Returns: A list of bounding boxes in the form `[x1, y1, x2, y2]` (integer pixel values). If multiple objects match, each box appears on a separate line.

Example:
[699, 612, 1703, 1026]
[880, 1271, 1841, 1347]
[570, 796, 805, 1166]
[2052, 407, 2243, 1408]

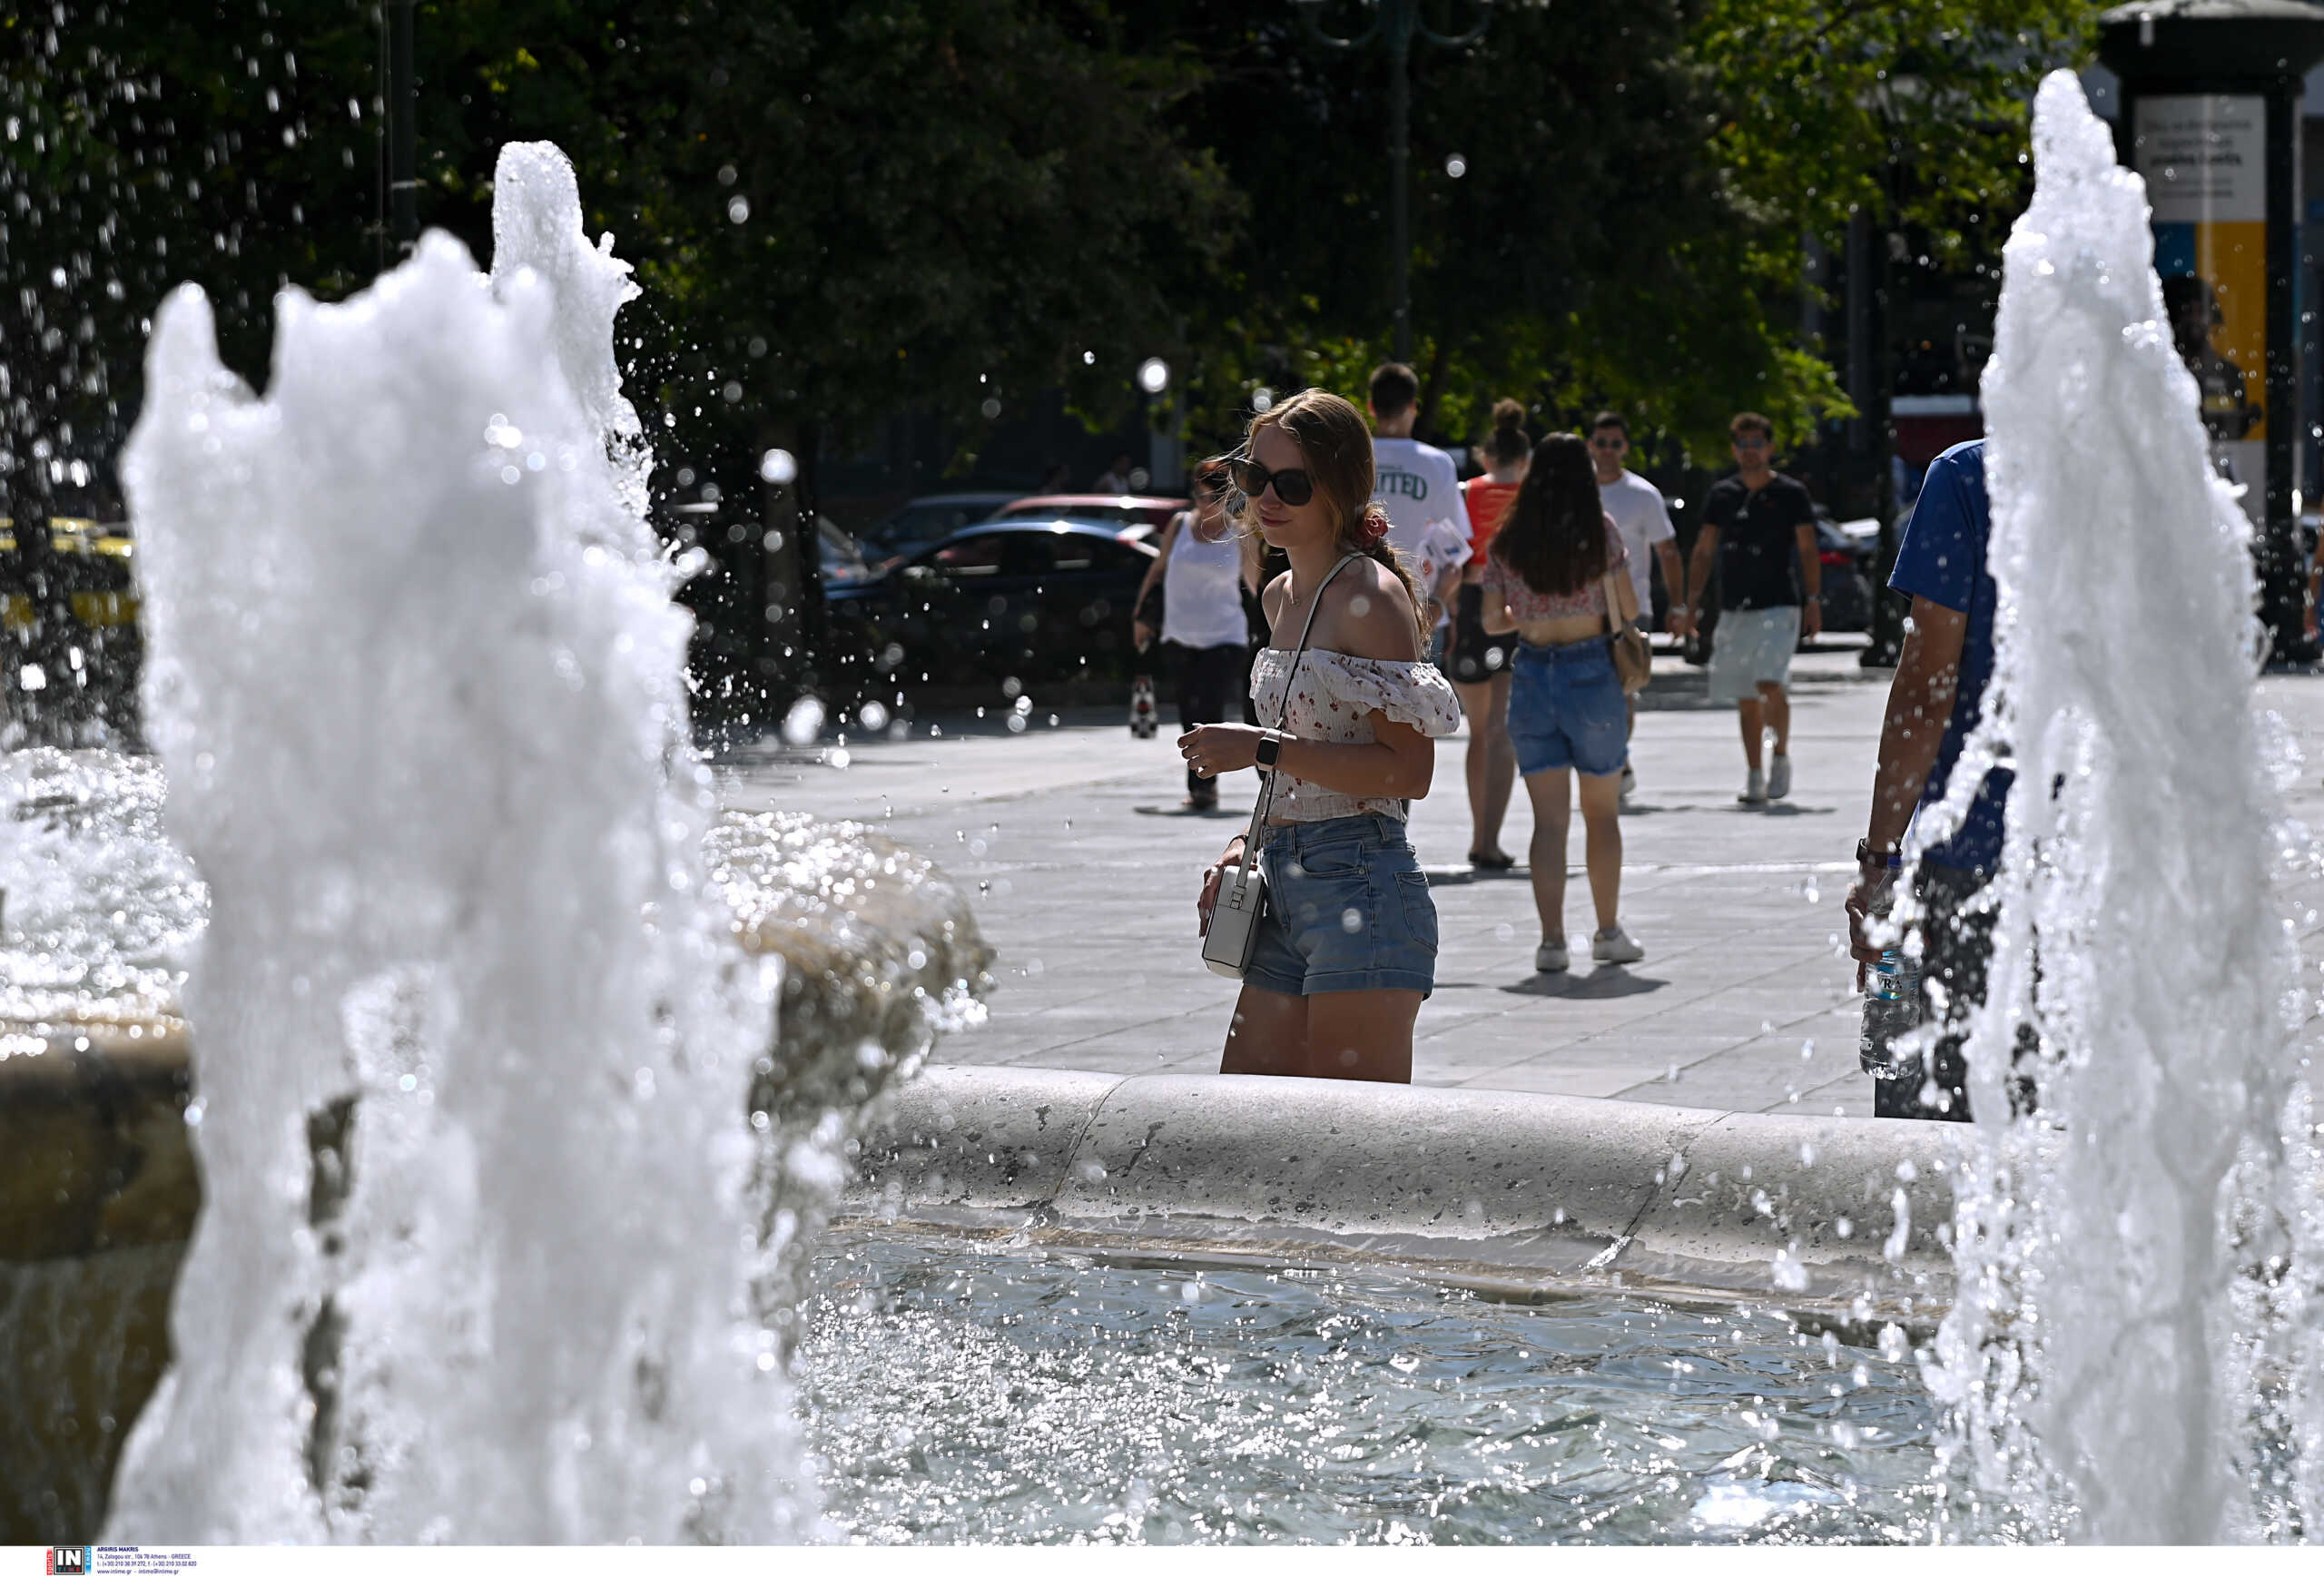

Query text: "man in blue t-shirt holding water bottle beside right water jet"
[1847, 439, 2010, 1122]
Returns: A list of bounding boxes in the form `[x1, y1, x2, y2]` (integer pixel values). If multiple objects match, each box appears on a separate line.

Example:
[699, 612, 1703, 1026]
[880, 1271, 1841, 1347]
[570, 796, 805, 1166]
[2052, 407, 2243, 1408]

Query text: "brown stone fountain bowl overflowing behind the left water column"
[0, 793, 990, 1544]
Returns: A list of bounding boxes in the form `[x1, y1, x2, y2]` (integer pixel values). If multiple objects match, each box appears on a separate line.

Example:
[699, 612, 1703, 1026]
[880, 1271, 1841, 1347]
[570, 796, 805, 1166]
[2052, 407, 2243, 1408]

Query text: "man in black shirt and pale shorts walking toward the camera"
[1688, 411, 1825, 806]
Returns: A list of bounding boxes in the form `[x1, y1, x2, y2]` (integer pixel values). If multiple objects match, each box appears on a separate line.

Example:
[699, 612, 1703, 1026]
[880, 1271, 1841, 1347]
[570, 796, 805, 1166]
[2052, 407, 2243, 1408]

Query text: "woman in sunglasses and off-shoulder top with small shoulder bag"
[1178, 388, 1460, 1085]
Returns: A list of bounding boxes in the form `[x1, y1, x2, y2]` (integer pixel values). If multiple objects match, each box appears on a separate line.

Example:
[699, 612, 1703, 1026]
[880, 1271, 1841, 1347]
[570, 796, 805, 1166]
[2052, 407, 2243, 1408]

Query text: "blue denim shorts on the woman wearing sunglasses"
[1244, 815, 1436, 996]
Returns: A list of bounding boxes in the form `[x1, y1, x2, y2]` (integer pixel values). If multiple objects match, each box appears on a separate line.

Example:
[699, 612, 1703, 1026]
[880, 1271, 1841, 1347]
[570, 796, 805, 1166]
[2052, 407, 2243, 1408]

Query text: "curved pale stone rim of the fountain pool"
[842, 1066, 1966, 1326]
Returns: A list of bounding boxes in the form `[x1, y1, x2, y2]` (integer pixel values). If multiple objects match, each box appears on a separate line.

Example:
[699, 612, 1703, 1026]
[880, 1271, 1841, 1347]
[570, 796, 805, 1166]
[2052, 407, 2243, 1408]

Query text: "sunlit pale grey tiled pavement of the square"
[721, 650, 2324, 1117]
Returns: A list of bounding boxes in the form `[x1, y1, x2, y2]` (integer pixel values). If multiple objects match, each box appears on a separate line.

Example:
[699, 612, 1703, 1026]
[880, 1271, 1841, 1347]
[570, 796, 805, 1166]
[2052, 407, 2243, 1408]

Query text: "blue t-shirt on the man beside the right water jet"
[1889, 439, 2010, 871]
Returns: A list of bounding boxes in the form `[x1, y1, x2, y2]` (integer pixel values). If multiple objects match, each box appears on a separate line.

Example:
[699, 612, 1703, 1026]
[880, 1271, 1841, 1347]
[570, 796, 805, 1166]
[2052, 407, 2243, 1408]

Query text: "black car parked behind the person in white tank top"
[825, 520, 1155, 685]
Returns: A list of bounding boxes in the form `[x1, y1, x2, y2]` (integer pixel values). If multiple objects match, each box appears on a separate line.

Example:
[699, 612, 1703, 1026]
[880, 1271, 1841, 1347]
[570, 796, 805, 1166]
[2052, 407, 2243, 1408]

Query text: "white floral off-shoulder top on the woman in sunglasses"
[1250, 646, 1460, 823]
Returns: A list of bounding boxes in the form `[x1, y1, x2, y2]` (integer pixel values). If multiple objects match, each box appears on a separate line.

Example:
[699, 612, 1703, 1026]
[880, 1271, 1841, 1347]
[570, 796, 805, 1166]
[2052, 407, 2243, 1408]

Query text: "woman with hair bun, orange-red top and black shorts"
[1445, 399, 1534, 871]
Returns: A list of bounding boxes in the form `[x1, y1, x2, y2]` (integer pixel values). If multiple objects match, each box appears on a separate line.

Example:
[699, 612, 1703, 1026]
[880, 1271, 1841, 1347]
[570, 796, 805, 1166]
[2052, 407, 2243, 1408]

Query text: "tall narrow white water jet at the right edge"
[1929, 72, 2324, 1543]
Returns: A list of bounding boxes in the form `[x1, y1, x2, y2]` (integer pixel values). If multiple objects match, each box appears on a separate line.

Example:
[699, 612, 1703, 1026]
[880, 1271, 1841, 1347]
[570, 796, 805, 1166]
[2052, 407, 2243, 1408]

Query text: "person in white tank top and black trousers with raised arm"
[1132, 460, 1257, 811]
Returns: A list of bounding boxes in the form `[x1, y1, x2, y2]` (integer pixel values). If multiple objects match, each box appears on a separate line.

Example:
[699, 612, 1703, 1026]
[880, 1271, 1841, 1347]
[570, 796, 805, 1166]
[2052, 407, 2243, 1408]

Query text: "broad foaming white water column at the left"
[107, 144, 813, 1543]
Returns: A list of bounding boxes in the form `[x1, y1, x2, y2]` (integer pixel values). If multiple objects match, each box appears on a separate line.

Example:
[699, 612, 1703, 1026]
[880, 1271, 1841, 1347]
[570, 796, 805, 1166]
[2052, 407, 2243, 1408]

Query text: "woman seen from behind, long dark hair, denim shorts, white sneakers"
[1485, 432, 1645, 973]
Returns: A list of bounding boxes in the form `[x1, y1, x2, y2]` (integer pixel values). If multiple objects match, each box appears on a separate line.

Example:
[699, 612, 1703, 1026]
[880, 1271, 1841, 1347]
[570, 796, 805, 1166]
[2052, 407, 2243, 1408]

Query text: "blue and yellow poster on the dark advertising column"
[2132, 93, 2269, 520]
